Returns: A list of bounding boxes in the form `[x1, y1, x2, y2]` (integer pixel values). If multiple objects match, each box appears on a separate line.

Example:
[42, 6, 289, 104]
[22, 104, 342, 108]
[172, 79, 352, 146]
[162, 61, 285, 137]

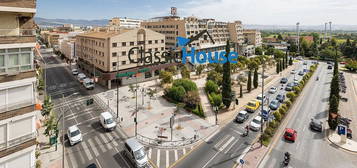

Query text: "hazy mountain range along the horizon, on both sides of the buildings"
[35, 17, 357, 32]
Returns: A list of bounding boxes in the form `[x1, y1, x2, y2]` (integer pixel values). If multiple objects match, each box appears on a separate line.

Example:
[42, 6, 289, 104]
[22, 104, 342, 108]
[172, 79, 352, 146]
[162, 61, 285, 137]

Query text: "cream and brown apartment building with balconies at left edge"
[0, 0, 39, 168]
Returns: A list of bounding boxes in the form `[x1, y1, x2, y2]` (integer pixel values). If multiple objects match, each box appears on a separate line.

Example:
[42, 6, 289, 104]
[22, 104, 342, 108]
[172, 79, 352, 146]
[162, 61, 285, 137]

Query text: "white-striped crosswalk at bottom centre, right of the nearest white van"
[147, 146, 193, 168]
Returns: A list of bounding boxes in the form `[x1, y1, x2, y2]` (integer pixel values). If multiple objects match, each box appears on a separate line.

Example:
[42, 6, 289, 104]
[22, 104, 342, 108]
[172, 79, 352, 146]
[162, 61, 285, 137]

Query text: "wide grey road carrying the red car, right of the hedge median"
[260, 63, 357, 168]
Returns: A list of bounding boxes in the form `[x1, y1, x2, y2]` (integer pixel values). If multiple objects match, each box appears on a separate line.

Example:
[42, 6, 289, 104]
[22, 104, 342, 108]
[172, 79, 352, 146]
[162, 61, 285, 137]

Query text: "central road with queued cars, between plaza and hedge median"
[174, 59, 306, 168]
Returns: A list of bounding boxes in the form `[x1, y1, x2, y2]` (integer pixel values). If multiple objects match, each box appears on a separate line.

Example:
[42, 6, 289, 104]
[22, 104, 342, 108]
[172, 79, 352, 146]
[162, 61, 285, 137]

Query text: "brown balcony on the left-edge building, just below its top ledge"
[0, 29, 36, 44]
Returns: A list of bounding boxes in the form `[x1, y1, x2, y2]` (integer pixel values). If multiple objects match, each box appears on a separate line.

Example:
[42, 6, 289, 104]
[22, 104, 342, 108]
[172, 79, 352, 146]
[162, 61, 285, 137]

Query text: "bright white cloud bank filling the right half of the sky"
[179, 0, 357, 25]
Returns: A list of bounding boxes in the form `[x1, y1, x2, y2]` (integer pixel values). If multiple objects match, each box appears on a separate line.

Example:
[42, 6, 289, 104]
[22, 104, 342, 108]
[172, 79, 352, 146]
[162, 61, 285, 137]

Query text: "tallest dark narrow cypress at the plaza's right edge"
[222, 41, 232, 108]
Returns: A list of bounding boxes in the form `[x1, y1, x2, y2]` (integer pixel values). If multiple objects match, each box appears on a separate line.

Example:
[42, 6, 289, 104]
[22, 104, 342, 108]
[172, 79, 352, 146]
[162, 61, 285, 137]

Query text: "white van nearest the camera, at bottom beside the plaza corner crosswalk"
[124, 138, 149, 168]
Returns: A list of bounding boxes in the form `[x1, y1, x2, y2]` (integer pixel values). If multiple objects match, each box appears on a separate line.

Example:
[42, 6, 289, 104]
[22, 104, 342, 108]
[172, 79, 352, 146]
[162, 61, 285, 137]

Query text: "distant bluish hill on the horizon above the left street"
[35, 17, 109, 26]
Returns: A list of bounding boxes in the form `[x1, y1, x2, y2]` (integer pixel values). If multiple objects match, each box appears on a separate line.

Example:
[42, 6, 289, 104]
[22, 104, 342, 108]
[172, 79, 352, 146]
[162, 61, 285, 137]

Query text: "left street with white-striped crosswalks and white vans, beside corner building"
[43, 53, 133, 168]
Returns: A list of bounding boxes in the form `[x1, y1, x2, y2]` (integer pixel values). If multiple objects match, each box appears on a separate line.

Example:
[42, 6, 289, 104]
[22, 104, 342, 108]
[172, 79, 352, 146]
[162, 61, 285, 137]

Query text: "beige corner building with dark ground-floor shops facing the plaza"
[76, 28, 176, 89]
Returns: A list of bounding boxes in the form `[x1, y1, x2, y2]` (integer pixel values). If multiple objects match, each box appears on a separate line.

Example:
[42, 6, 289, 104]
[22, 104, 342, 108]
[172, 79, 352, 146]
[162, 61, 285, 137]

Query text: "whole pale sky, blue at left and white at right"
[36, 0, 357, 25]
